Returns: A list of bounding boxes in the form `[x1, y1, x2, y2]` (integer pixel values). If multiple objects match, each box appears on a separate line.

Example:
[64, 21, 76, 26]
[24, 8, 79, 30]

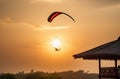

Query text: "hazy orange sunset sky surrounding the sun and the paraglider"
[0, 0, 120, 72]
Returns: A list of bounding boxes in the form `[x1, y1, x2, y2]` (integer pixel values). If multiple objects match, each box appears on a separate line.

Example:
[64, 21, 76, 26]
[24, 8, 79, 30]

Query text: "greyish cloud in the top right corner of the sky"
[74, 0, 120, 10]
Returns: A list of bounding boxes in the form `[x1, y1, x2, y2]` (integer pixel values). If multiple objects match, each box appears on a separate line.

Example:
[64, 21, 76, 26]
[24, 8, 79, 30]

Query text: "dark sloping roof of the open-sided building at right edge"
[73, 37, 120, 60]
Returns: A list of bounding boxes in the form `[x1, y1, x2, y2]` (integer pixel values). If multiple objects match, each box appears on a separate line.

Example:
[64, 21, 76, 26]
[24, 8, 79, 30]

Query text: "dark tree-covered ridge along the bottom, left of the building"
[0, 70, 98, 79]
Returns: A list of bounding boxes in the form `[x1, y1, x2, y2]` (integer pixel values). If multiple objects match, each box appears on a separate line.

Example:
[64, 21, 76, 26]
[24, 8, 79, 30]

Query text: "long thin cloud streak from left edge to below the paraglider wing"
[0, 17, 69, 30]
